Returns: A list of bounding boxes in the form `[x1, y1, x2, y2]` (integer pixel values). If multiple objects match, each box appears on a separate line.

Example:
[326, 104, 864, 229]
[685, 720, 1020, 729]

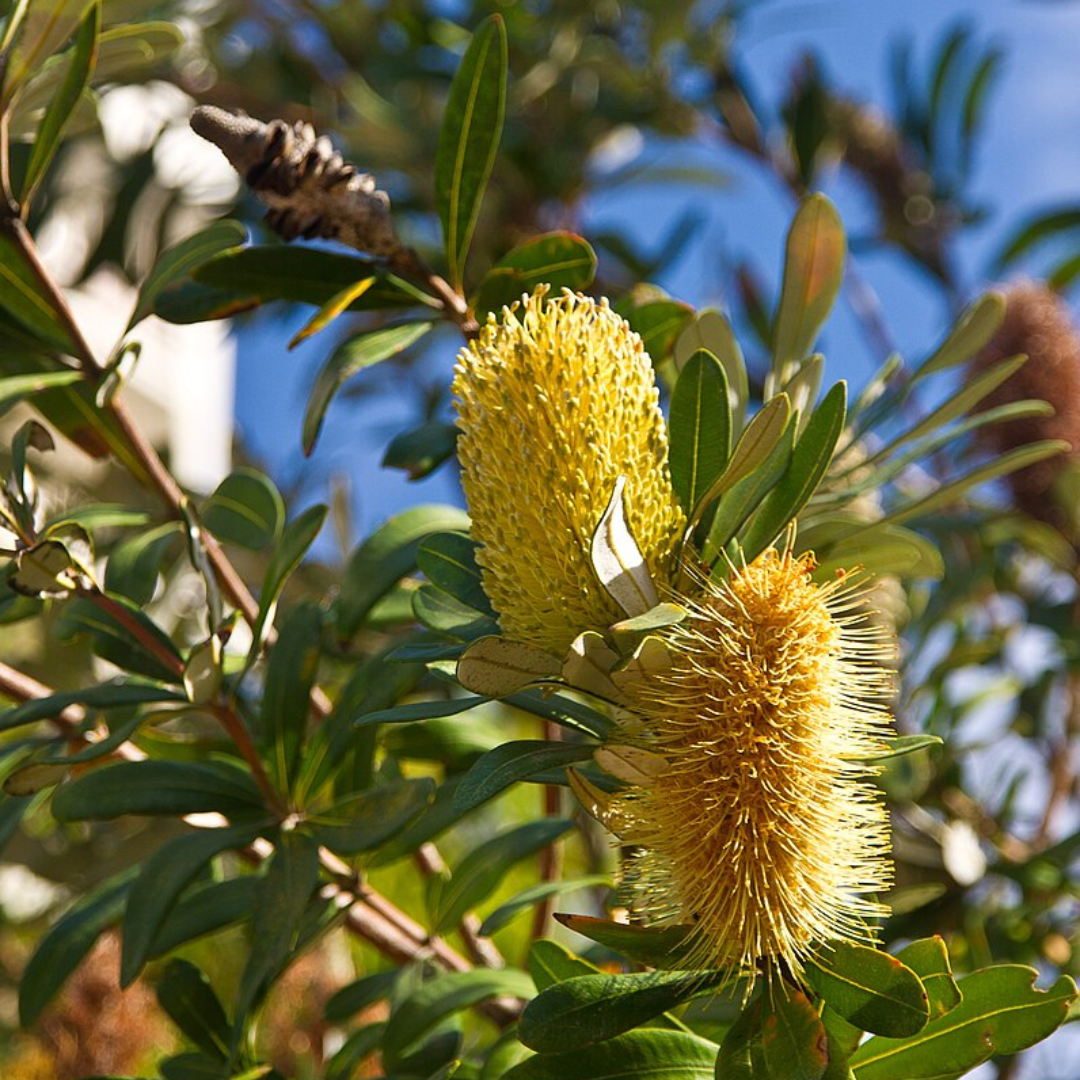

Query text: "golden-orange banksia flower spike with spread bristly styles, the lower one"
[612, 550, 894, 980]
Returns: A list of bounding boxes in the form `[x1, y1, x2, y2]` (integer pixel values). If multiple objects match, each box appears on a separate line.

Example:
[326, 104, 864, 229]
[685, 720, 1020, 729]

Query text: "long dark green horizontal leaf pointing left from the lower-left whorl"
[53, 761, 262, 821]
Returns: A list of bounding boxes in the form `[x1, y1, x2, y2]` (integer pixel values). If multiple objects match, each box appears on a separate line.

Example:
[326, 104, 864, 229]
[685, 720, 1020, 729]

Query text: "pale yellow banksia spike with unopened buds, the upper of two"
[454, 287, 685, 656]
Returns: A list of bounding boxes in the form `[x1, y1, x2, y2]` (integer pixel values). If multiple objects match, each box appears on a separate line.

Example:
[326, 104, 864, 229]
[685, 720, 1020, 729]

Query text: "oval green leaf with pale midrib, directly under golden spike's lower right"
[806, 942, 930, 1039]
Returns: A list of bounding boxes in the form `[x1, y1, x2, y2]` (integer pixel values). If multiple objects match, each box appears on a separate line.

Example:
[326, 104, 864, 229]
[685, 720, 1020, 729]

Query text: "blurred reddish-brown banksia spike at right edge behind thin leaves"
[970, 282, 1080, 528]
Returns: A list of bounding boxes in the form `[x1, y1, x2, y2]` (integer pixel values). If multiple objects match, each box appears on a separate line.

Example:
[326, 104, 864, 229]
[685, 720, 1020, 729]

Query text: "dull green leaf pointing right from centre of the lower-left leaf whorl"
[309, 777, 435, 855]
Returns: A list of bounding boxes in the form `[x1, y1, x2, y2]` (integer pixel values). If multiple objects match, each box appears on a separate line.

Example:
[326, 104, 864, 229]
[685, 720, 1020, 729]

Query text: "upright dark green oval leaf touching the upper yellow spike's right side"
[669, 350, 731, 515]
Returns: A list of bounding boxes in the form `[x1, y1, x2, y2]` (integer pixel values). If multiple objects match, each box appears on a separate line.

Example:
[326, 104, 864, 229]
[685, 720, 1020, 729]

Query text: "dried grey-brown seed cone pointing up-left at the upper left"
[191, 105, 406, 260]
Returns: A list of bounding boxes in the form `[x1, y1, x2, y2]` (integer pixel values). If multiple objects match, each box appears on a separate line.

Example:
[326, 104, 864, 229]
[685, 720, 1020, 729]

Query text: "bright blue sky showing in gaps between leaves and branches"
[237, 0, 1080, 540]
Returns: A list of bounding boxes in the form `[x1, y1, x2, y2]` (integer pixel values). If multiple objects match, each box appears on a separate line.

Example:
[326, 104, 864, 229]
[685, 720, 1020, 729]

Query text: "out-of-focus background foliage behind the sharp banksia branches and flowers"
[0, 0, 1080, 1080]
